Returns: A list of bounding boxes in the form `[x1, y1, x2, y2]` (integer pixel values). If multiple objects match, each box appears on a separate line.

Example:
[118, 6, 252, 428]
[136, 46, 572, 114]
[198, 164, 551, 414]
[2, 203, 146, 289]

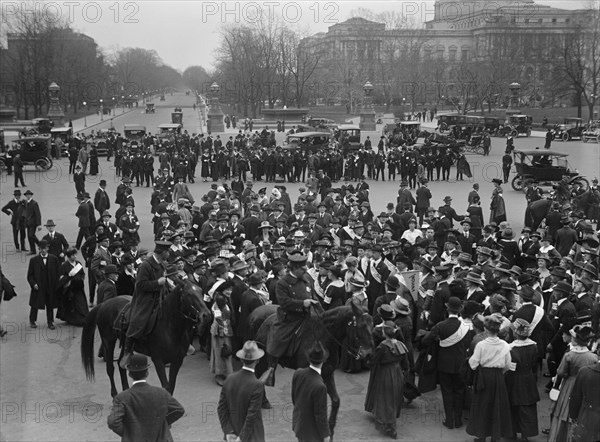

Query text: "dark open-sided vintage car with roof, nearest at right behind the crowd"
[511, 149, 590, 191]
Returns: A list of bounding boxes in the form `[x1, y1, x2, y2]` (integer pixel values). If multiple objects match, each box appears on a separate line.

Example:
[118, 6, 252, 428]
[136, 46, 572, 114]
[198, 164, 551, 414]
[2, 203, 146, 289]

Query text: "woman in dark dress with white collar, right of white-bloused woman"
[505, 318, 540, 441]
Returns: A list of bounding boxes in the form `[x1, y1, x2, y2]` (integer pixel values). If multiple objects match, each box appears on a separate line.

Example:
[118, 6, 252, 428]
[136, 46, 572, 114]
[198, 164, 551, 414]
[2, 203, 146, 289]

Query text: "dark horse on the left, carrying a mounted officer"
[81, 281, 211, 397]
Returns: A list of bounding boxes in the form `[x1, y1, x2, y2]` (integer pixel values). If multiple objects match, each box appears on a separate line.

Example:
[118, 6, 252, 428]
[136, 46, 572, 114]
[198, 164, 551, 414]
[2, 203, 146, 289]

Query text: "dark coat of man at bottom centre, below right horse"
[292, 367, 329, 441]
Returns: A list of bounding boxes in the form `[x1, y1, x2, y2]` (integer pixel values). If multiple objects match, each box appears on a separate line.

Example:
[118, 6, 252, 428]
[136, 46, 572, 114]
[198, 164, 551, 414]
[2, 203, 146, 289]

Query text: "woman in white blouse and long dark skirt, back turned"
[467, 315, 513, 441]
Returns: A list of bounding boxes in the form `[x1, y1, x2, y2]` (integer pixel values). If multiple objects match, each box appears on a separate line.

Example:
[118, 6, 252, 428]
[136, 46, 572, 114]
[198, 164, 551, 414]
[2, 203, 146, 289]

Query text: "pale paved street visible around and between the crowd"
[0, 94, 600, 441]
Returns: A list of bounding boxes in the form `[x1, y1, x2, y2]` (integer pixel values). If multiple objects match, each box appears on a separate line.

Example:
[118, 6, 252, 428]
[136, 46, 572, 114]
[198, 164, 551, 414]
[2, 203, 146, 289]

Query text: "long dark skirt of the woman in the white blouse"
[467, 367, 514, 439]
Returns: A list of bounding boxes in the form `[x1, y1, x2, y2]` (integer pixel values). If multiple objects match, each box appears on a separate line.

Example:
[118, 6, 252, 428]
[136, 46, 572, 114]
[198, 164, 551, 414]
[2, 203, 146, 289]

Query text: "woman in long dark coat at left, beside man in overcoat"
[56, 248, 89, 326]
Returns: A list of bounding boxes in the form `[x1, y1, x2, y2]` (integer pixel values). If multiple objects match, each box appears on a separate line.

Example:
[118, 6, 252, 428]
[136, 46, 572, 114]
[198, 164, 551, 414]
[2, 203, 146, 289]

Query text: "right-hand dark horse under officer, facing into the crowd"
[248, 304, 374, 440]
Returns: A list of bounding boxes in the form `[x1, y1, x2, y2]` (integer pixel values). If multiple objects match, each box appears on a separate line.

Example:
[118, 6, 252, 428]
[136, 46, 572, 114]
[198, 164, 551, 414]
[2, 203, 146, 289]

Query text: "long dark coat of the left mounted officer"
[127, 256, 165, 338]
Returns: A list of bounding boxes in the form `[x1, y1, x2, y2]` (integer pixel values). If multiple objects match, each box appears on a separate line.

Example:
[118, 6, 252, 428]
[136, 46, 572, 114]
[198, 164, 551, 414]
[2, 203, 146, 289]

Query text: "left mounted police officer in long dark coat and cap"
[119, 241, 172, 368]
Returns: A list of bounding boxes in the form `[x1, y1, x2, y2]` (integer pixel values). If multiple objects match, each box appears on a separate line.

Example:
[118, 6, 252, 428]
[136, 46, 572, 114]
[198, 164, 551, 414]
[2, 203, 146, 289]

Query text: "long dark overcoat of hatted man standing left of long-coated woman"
[27, 254, 60, 310]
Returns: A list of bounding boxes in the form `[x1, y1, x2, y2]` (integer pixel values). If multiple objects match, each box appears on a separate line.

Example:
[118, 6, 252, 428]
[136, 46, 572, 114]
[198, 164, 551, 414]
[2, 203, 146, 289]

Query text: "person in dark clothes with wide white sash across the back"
[423, 296, 474, 429]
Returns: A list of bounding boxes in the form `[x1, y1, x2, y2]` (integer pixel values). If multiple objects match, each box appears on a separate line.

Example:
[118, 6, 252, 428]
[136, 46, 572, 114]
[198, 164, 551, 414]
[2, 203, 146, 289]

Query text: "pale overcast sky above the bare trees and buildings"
[19, 0, 598, 71]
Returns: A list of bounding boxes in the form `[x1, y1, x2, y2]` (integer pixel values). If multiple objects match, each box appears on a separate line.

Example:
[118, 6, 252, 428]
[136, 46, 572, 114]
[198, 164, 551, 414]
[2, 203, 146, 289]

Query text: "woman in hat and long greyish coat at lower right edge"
[548, 325, 598, 442]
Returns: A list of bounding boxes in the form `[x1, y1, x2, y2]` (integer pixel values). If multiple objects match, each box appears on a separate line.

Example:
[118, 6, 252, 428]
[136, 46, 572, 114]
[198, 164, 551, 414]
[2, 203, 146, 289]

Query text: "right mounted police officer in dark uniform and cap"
[265, 250, 322, 387]
